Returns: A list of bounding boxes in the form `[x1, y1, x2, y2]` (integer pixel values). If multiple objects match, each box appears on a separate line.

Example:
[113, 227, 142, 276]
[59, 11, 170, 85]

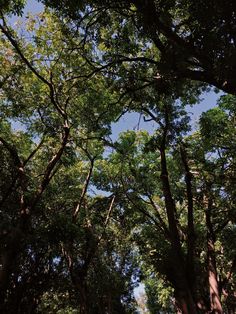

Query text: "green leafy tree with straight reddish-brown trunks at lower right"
[93, 93, 235, 313]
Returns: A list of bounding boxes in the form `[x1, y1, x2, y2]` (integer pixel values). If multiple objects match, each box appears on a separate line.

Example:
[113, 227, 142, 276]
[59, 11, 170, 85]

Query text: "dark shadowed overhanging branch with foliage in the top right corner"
[43, 0, 236, 95]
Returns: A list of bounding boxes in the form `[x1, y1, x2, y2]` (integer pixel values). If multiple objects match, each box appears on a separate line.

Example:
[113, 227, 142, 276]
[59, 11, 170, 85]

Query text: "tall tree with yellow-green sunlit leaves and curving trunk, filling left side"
[0, 12, 136, 313]
